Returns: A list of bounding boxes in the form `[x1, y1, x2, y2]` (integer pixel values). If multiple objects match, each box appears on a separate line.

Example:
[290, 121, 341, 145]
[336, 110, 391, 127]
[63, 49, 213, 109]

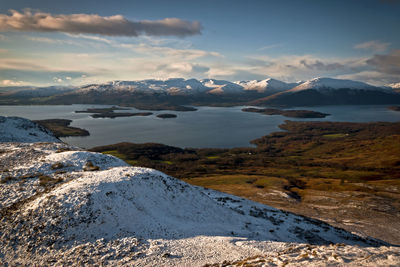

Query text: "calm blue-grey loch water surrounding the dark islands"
[0, 105, 400, 148]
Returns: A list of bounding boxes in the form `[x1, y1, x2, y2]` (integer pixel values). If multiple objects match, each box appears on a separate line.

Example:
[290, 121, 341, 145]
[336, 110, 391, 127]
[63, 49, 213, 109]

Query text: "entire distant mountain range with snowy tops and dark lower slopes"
[0, 78, 400, 109]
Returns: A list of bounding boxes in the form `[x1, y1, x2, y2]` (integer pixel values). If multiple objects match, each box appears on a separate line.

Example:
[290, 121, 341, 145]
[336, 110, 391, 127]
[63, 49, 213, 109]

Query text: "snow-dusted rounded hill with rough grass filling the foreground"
[0, 117, 400, 266]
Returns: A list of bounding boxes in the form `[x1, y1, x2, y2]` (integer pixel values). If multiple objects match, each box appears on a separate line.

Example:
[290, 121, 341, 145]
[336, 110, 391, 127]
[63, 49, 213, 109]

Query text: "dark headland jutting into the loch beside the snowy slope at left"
[34, 119, 90, 137]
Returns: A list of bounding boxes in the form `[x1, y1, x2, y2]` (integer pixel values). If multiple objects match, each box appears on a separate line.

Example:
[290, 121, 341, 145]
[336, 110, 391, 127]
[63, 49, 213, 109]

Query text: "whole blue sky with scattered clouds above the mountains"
[0, 0, 400, 86]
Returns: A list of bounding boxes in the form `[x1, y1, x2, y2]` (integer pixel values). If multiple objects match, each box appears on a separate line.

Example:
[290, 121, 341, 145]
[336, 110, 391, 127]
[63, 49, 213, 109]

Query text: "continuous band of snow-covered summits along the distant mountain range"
[73, 78, 390, 95]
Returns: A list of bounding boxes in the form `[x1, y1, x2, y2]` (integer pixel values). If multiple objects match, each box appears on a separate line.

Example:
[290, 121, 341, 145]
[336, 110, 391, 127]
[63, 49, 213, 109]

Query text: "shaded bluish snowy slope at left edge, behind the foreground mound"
[0, 116, 61, 143]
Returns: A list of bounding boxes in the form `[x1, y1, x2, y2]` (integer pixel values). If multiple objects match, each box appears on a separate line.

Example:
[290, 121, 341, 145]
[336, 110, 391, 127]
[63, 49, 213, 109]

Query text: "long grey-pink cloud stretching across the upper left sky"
[0, 9, 202, 37]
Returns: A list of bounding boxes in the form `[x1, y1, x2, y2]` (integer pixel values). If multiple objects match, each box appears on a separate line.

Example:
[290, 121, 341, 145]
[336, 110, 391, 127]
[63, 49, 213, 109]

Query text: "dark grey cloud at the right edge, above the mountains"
[367, 49, 400, 75]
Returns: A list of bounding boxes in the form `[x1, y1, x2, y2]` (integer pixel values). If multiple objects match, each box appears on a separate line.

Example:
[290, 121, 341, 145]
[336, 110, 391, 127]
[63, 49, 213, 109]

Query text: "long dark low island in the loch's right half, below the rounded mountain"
[242, 108, 330, 118]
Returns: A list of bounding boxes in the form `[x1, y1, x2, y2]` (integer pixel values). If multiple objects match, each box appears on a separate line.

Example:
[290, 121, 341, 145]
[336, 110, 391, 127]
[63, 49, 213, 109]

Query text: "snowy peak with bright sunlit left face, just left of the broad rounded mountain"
[235, 78, 298, 93]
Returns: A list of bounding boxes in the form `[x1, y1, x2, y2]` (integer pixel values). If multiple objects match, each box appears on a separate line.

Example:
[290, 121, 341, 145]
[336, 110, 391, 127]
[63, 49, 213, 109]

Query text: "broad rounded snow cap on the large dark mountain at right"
[290, 78, 379, 92]
